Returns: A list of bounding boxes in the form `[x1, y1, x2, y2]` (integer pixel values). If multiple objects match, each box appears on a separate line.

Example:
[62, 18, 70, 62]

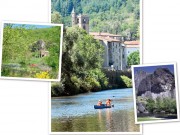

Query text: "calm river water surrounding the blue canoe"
[51, 89, 139, 132]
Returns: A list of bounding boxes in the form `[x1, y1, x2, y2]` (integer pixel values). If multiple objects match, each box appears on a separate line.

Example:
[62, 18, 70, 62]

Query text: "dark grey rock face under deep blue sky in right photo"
[135, 68, 175, 99]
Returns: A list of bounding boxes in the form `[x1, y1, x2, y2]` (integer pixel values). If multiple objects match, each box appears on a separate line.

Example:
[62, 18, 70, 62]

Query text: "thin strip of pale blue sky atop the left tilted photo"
[4, 23, 54, 29]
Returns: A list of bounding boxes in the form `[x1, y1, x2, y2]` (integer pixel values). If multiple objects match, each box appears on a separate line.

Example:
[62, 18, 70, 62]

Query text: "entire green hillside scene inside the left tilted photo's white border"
[1, 23, 61, 79]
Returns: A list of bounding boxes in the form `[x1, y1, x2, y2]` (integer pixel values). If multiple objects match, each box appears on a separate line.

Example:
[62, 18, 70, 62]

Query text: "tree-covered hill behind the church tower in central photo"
[51, 0, 140, 39]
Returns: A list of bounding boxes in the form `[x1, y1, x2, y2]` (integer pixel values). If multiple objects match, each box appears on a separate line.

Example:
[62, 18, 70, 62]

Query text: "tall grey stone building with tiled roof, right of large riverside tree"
[89, 32, 126, 70]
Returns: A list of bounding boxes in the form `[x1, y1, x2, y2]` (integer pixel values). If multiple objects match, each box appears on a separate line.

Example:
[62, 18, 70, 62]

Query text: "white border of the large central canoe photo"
[49, 0, 143, 135]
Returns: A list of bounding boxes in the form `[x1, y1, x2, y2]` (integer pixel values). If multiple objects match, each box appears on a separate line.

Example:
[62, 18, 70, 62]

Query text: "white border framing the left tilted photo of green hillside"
[0, 21, 64, 82]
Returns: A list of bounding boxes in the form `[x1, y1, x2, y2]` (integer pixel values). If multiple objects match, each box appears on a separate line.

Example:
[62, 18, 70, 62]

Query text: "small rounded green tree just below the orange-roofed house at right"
[127, 51, 140, 67]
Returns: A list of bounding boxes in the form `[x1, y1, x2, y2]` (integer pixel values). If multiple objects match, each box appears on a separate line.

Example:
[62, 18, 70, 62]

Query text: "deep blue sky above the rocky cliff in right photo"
[134, 64, 174, 74]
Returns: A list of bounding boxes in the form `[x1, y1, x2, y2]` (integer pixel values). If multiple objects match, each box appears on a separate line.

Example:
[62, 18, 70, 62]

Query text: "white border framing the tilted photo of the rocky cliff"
[131, 62, 180, 124]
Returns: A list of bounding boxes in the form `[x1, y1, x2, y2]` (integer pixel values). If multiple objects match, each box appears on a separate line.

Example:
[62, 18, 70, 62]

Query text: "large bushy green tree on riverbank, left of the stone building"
[52, 27, 108, 96]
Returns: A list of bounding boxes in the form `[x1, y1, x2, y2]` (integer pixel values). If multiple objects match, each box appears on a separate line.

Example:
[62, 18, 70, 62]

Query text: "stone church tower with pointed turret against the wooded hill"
[71, 8, 89, 33]
